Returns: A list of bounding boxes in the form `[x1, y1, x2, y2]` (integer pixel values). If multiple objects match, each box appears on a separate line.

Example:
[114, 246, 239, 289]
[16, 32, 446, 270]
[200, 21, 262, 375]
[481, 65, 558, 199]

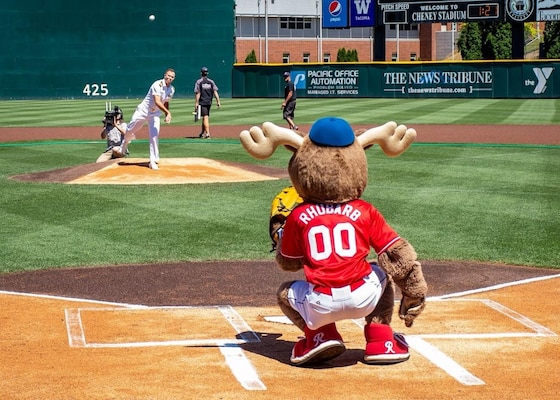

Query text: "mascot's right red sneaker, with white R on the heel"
[364, 324, 410, 365]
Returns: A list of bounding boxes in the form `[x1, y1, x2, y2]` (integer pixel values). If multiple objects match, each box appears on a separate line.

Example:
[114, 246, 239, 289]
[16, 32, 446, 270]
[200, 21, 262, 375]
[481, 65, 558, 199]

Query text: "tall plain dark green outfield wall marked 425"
[0, 0, 235, 100]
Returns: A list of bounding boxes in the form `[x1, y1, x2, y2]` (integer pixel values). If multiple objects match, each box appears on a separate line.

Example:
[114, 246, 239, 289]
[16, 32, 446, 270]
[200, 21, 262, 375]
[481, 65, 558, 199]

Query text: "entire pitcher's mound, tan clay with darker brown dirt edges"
[12, 158, 288, 185]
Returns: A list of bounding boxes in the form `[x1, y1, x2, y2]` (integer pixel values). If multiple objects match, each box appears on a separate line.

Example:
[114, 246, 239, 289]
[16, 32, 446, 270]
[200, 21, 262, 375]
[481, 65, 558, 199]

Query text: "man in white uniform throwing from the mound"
[123, 68, 175, 169]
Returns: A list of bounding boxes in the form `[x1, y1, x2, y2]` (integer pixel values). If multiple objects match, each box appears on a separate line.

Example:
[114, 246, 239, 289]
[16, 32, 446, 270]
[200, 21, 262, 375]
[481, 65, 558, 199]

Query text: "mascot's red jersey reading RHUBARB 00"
[280, 199, 400, 287]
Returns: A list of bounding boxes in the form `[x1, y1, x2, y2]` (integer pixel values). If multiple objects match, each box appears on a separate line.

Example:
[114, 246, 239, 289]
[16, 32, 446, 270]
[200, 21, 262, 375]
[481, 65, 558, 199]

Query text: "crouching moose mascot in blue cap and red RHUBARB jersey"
[240, 117, 427, 365]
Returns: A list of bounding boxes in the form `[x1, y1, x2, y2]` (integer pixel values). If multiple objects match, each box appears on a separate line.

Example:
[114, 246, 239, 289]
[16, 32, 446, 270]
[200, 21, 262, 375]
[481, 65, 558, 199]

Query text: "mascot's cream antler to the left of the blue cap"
[239, 122, 303, 160]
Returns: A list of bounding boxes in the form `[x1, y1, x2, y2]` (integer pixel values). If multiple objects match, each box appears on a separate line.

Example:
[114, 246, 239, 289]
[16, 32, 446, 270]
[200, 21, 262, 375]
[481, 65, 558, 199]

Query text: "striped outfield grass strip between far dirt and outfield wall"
[0, 98, 560, 127]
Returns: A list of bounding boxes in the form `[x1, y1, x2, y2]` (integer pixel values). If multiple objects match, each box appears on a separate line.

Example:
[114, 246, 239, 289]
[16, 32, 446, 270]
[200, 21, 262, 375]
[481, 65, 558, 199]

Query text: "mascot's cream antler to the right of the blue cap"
[358, 121, 416, 157]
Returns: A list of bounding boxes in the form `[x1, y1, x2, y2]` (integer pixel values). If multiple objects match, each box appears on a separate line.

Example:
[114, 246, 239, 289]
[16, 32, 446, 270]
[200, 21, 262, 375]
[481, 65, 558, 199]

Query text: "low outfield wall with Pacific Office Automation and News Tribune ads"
[232, 60, 560, 98]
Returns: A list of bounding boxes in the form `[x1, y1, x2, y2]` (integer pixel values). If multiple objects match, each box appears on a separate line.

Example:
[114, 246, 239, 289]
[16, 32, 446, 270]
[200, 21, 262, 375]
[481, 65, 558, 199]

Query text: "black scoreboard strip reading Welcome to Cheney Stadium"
[376, 0, 505, 25]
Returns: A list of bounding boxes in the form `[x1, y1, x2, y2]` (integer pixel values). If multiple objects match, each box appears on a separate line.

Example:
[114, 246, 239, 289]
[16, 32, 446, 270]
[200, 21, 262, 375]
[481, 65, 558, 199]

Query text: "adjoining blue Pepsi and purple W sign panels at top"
[323, 0, 376, 28]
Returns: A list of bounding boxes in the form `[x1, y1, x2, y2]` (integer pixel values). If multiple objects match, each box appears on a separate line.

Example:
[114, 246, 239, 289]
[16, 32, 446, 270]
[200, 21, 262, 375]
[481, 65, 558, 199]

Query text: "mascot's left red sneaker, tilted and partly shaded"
[290, 323, 346, 365]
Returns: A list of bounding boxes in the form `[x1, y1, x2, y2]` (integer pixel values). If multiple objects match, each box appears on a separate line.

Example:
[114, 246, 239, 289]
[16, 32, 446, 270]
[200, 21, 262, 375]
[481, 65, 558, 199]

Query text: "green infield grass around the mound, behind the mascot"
[0, 140, 560, 272]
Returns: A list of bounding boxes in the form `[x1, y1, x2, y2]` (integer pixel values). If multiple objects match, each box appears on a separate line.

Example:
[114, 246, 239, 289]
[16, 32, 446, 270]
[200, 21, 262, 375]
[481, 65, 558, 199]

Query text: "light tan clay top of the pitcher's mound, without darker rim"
[67, 157, 279, 185]
